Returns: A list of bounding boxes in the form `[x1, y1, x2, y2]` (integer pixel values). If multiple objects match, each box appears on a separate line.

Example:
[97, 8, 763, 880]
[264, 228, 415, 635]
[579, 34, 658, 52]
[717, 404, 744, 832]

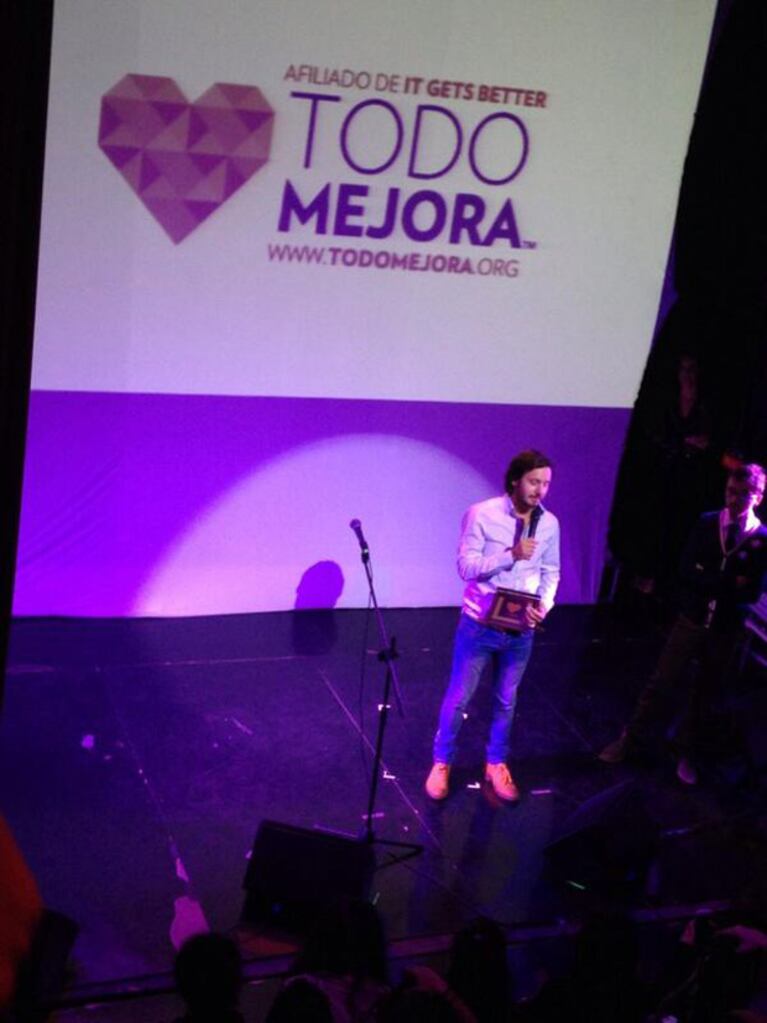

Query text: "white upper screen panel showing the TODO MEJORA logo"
[33, 0, 715, 407]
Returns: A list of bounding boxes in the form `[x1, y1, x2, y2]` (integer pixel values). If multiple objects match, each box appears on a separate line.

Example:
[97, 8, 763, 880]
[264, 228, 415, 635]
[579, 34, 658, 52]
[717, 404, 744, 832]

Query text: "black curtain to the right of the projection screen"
[610, 0, 767, 589]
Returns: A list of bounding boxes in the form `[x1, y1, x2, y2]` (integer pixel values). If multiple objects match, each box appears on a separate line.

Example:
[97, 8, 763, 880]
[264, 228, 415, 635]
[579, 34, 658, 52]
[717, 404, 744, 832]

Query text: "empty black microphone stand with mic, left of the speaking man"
[350, 519, 423, 868]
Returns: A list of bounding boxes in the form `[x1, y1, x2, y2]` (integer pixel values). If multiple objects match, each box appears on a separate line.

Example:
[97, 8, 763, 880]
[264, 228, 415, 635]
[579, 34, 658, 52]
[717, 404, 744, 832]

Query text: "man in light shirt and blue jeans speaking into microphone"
[425, 450, 559, 802]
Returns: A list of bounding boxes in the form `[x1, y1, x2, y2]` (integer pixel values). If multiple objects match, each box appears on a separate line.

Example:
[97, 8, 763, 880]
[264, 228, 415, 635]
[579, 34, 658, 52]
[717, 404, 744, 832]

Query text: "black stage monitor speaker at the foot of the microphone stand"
[241, 820, 375, 933]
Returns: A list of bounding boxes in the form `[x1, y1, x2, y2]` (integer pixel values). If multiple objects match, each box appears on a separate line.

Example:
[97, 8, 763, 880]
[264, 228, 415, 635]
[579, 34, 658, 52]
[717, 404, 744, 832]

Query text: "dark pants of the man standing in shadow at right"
[626, 615, 740, 756]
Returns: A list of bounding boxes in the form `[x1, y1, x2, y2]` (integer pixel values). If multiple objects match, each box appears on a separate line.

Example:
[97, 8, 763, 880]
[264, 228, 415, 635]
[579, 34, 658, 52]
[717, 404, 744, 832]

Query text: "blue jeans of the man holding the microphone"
[434, 615, 533, 764]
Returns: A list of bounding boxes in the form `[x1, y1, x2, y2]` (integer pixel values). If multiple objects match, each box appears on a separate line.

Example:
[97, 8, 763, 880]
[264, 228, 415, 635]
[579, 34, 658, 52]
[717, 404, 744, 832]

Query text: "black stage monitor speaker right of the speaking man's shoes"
[545, 782, 658, 897]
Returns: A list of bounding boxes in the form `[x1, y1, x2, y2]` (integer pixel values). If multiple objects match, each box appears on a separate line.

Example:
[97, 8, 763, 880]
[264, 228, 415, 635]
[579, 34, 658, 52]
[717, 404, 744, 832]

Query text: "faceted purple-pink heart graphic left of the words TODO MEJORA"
[98, 75, 274, 243]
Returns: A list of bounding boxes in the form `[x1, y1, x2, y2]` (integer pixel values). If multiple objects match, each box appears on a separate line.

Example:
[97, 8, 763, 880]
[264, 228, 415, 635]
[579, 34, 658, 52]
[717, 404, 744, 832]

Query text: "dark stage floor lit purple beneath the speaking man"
[0, 607, 764, 1002]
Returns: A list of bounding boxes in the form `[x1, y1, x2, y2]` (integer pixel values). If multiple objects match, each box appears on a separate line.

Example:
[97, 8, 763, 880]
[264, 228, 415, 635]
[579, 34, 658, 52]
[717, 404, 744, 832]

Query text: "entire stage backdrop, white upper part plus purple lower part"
[15, 0, 715, 615]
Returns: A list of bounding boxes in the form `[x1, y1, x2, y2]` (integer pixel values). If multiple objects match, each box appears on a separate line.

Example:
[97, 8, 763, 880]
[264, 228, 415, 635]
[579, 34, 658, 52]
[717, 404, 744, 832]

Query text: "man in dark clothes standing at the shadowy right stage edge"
[599, 464, 767, 785]
